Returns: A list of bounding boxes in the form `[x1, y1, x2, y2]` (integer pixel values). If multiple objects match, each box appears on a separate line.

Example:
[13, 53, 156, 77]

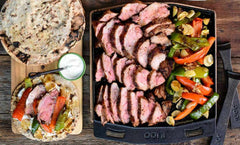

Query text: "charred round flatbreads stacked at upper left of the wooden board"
[0, 0, 85, 65]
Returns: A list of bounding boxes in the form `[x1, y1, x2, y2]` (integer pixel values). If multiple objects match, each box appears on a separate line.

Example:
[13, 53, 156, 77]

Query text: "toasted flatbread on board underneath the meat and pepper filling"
[11, 74, 80, 142]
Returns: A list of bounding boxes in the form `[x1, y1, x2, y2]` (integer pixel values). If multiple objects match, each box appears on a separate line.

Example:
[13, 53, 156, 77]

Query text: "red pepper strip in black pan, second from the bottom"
[182, 93, 208, 105]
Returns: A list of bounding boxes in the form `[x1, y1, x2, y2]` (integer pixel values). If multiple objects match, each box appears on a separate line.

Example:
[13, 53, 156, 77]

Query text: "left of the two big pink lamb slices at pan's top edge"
[118, 2, 147, 21]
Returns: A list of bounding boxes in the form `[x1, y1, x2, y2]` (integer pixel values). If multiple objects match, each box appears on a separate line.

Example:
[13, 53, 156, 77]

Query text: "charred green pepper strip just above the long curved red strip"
[171, 32, 209, 51]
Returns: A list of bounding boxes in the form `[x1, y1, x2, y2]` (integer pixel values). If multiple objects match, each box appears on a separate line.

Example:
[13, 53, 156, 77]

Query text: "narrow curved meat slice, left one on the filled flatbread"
[25, 85, 46, 115]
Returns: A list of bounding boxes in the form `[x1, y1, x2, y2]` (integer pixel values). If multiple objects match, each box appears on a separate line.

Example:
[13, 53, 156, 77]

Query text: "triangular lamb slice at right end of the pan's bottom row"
[148, 102, 166, 126]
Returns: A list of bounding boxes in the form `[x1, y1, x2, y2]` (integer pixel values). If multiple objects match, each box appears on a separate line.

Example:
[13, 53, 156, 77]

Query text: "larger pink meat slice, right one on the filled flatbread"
[37, 89, 59, 125]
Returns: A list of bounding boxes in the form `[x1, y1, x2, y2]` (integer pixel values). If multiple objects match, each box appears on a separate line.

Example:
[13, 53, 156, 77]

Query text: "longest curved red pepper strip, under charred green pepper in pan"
[173, 37, 215, 64]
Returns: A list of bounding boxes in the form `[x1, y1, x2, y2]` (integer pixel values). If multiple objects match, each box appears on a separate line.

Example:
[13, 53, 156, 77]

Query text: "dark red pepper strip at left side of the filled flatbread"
[12, 88, 32, 121]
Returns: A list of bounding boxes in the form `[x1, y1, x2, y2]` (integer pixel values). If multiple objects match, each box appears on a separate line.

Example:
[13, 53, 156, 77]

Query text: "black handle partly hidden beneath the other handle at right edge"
[218, 42, 240, 129]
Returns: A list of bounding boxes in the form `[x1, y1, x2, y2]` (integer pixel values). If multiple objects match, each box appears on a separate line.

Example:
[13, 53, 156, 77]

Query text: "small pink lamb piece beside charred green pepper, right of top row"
[150, 33, 171, 46]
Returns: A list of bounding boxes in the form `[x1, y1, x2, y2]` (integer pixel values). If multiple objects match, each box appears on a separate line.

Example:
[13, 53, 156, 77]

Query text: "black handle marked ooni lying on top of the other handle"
[211, 71, 240, 145]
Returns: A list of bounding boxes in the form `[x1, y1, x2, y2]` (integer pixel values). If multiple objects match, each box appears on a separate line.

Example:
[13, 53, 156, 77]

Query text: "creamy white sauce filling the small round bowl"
[59, 53, 85, 80]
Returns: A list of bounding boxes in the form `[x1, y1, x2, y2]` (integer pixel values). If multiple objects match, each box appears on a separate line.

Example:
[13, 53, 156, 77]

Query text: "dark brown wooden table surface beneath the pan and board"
[0, 0, 240, 145]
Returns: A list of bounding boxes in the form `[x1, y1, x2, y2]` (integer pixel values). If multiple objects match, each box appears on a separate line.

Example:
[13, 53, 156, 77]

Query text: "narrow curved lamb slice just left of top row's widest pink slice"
[110, 24, 124, 56]
